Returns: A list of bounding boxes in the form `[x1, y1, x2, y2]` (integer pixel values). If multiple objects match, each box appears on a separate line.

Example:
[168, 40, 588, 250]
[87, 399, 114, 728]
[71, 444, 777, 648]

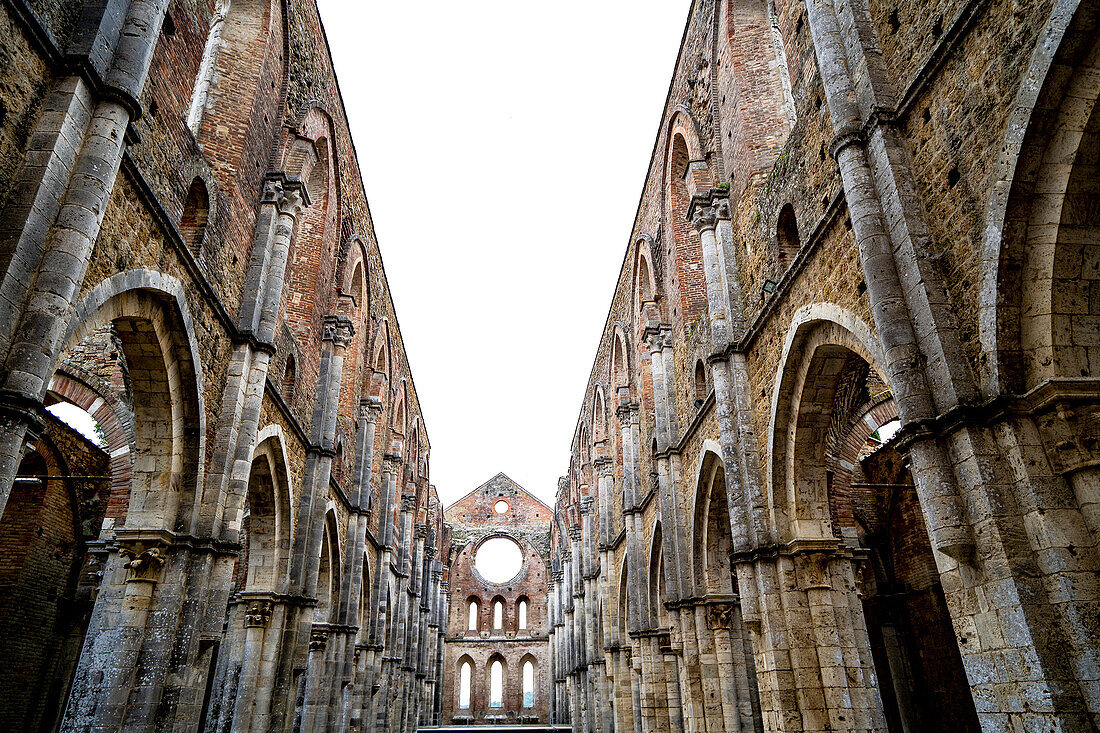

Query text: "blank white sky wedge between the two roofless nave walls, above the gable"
[319, 0, 691, 505]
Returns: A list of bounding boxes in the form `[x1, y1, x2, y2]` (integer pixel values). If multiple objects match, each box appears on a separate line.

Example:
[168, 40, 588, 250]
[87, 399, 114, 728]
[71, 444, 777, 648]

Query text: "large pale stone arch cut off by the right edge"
[979, 0, 1100, 396]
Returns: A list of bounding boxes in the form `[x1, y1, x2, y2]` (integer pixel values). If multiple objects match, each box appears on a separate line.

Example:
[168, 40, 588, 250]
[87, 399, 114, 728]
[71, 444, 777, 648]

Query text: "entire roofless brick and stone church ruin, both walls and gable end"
[0, 0, 1100, 733]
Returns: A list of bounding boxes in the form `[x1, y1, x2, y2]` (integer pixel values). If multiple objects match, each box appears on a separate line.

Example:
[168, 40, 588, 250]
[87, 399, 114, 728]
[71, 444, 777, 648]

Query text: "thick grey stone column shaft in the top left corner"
[0, 0, 168, 515]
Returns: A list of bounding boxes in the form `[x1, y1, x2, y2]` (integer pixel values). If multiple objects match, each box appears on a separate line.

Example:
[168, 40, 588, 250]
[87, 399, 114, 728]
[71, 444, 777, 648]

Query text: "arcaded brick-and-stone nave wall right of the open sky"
[549, 0, 1100, 733]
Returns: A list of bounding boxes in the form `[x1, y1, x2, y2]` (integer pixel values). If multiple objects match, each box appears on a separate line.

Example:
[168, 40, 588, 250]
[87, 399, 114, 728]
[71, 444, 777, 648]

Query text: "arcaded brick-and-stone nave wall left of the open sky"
[0, 0, 448, 733]
